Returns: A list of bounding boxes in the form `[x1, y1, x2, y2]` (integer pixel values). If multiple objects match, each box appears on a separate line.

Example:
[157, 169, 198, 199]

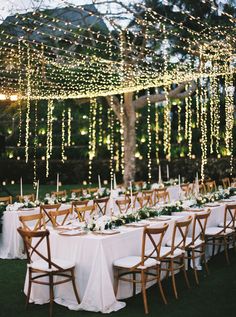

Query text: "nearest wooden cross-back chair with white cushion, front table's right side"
[113, 224, 168, 314]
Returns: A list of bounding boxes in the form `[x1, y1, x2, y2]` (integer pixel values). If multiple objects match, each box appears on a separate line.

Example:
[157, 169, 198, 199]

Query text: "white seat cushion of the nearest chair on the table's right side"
[113, 256, 159, 270]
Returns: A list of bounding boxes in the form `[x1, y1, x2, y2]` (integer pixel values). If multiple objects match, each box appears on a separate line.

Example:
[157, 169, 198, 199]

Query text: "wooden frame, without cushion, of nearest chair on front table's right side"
[114, 224, 168, 314]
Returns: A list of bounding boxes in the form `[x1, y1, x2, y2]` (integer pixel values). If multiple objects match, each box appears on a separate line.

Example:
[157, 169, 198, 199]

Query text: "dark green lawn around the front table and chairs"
[0, 250, 236, 317]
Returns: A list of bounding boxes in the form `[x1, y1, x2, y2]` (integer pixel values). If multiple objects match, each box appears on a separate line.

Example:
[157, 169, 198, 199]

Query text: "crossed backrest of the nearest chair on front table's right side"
[138, 223, 169, 266]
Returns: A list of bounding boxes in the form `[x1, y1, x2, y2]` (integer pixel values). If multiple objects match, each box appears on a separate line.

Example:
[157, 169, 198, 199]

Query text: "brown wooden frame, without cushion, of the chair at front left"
[17, 228, 80, 317]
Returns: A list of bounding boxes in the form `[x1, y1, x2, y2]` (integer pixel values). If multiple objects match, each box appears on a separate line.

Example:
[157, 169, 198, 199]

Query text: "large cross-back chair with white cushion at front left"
[17, 228, 80, 317]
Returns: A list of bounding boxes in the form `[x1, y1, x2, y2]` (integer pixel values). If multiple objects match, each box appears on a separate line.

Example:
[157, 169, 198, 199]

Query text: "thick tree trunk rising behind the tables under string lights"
[124, 93, 136, 186]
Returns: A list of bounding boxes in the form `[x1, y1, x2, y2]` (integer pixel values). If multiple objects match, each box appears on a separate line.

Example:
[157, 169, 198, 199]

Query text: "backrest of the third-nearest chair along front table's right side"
[191, 209, 211, 244]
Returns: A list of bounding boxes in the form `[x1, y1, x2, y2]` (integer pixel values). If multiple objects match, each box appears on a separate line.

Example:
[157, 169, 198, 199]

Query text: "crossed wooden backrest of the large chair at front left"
[17, 228, 62, 270]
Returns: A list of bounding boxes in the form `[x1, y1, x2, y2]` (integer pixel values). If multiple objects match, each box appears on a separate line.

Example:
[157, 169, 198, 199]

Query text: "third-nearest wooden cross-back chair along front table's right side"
[185, 209, 211, 284]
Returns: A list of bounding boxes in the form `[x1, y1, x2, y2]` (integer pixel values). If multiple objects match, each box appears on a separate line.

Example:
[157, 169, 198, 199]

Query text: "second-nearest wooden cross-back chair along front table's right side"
[160, 216, 192, 298]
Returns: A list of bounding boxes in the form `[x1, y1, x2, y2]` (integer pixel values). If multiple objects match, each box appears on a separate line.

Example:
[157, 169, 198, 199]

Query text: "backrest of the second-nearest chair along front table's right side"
[170, 216, 192, 254]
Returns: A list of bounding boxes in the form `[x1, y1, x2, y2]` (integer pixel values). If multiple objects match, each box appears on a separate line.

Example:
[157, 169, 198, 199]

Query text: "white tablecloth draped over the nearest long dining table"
[21, 196, 232, 313]
